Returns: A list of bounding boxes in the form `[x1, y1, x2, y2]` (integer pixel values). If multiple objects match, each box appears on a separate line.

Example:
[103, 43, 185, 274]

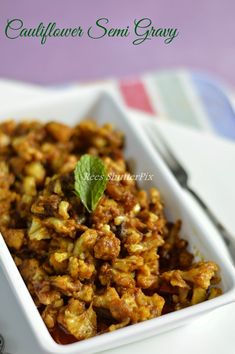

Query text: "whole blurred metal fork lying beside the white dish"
[145, 124, 234, 259]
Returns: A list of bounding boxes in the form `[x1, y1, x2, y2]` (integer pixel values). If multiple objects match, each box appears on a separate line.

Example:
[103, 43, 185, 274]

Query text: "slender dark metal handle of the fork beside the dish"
[186, 186, 233, 246]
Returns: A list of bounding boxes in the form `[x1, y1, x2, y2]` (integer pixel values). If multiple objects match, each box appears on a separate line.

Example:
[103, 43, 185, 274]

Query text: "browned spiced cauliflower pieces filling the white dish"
[0, 120, 221, 344]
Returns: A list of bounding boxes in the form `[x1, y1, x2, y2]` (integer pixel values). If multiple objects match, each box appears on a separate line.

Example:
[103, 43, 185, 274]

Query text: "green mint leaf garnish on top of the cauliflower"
[74, 154, 108, 213]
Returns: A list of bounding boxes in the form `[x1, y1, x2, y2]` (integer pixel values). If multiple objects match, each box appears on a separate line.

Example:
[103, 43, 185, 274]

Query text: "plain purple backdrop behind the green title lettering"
[0, 0, 235, 86]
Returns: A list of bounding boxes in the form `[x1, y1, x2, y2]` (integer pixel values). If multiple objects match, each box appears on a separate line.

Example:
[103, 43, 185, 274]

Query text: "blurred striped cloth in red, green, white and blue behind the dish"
[118, 70, 235, 139]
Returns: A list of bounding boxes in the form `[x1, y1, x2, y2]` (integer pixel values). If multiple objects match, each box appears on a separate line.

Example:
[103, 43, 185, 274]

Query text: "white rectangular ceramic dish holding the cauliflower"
[0, 89, 235, 354]
